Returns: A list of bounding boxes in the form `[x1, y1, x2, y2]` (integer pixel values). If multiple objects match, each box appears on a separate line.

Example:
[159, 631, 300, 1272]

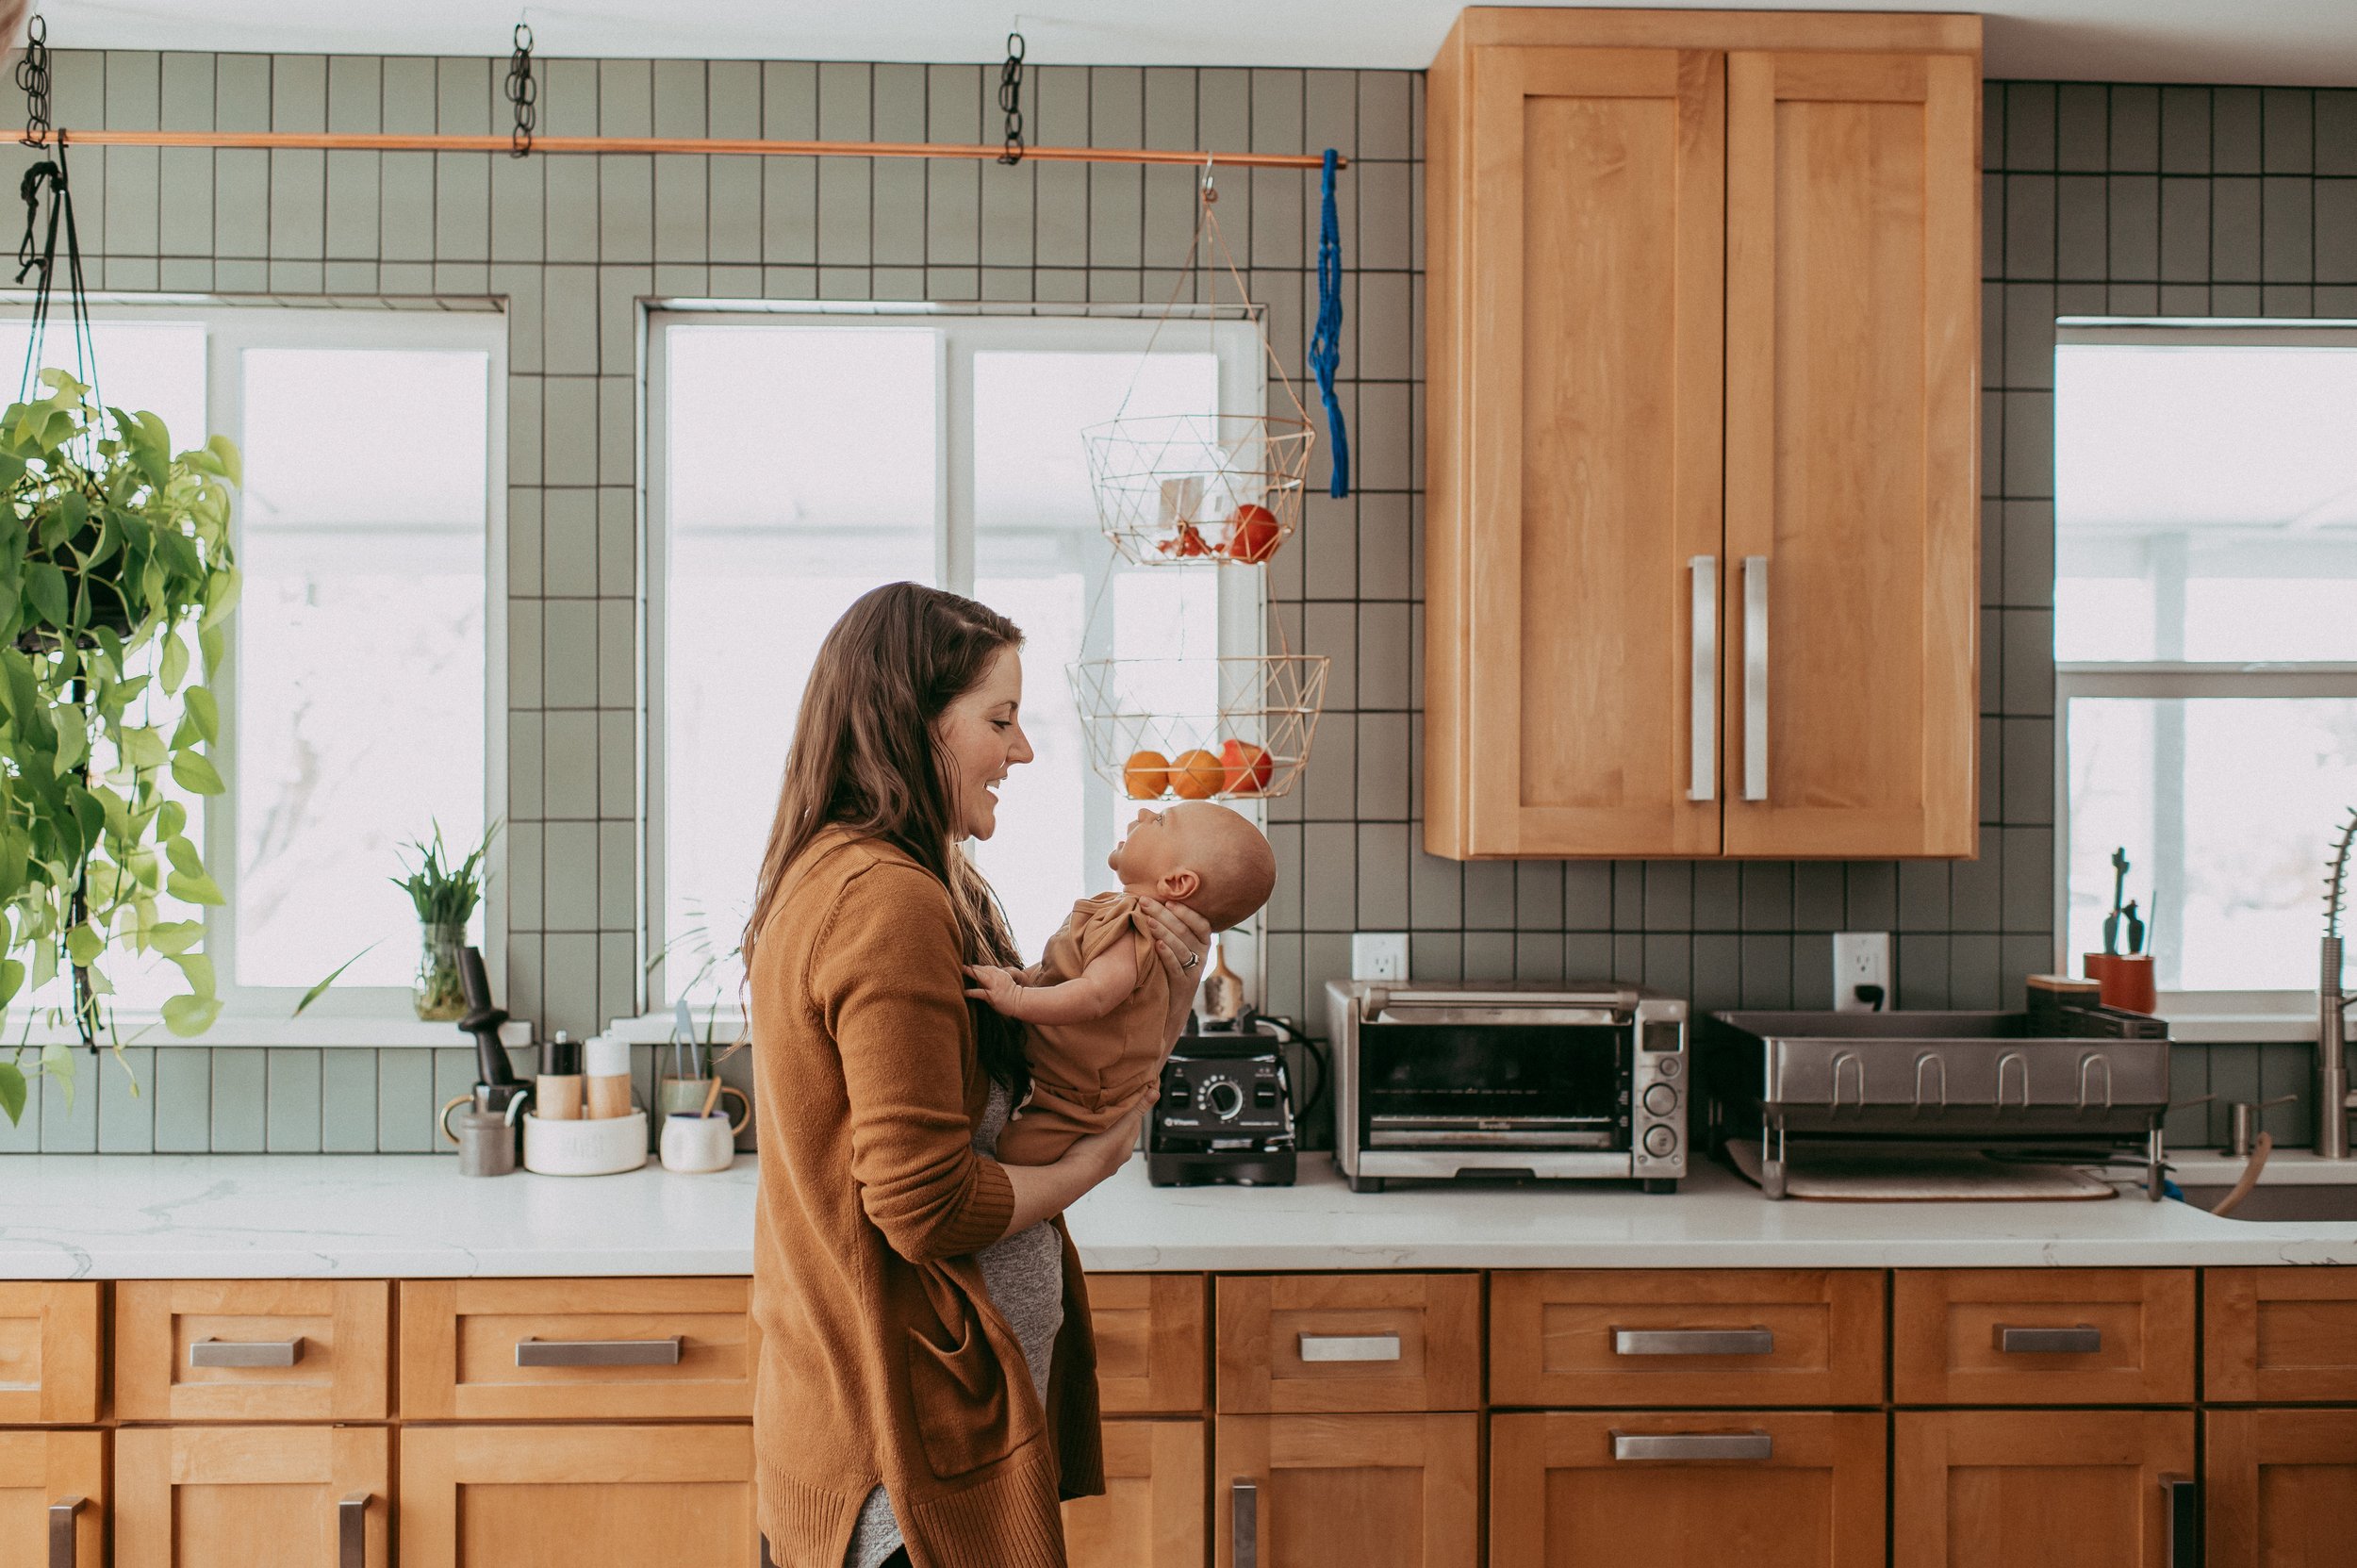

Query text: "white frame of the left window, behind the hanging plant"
[0, 295, 507, 1047]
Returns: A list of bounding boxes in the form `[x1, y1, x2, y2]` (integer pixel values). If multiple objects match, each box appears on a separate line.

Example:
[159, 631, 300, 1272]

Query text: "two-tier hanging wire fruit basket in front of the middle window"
[1068, 168, 1327, 800]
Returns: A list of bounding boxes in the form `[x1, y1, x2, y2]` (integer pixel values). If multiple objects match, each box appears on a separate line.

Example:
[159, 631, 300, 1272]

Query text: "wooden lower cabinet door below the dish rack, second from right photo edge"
[1890, 1410, 2200, 1568]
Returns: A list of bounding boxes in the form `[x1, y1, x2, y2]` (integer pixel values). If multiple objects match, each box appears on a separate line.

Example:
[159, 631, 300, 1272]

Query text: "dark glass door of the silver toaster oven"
[1358, 1023, 1631, 1150]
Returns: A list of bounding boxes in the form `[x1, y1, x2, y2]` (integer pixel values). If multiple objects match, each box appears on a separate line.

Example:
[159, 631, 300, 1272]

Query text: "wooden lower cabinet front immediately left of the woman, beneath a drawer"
[393, 1424, 762, 1568]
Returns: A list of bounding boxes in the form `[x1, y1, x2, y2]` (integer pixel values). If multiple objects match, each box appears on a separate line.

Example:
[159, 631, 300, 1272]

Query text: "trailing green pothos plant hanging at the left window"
[0, 371, 240, 1122]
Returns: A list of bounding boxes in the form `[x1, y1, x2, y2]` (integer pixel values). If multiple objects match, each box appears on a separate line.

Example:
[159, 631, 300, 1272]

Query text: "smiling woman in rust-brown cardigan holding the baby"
[745, 583, 1210, 1568]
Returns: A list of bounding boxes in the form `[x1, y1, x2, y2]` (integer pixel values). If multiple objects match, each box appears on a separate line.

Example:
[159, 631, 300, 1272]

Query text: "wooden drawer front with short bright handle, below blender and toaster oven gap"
[1219, 1273, 1480, 1412]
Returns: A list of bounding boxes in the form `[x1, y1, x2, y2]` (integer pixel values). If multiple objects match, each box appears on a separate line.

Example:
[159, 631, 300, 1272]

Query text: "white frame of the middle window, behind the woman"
[641, 300, 1268, 1042]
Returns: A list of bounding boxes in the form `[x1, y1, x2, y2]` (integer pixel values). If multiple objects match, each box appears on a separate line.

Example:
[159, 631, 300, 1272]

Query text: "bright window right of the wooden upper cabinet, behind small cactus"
[2055, 321, 2357, 993]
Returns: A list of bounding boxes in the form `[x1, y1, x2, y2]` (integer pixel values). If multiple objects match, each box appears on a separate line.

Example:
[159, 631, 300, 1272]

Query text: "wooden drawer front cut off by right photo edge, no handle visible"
[2201, 1268, 2357, 1403]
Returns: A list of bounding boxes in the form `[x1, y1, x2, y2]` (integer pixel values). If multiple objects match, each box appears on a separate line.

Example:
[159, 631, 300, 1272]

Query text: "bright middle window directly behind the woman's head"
[649, 311, 1263, 1004]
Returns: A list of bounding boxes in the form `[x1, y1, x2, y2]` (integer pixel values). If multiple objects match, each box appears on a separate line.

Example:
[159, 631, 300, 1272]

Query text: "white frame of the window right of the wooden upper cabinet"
[2053, 316, 2357, 1040]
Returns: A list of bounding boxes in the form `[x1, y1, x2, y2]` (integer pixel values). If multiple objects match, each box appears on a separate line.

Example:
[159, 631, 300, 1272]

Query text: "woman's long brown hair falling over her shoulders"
[745, 583, 1026, 1092]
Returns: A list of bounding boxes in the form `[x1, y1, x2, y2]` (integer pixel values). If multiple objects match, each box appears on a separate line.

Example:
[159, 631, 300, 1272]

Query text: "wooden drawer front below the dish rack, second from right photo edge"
[1890, 1268, 2195, 1405]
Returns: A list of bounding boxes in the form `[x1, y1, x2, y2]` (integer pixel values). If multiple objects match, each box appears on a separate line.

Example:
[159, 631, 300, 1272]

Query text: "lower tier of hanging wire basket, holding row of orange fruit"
[1068, 653, 1327, 800]
